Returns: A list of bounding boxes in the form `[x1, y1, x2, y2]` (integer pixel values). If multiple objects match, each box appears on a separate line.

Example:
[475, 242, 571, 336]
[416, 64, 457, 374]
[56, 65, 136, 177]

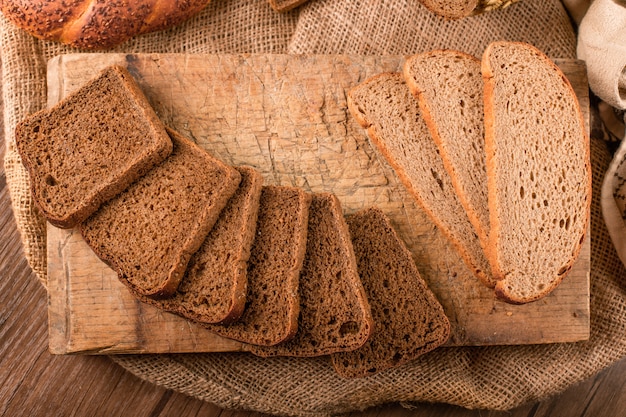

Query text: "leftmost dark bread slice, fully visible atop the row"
[15, 66, 172, 228]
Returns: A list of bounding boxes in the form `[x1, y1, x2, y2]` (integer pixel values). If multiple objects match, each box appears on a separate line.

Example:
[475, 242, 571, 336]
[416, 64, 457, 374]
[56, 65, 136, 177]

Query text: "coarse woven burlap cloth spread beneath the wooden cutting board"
[0, 0, 626, 416]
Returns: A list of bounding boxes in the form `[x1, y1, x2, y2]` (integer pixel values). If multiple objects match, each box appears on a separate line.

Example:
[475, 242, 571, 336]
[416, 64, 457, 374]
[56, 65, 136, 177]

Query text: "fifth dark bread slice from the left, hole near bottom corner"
[251, 193, 373, 357]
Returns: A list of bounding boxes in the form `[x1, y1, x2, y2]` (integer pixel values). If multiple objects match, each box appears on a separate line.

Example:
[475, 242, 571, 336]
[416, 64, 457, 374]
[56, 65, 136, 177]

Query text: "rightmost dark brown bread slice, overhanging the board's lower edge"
[331, 207, 450, 378]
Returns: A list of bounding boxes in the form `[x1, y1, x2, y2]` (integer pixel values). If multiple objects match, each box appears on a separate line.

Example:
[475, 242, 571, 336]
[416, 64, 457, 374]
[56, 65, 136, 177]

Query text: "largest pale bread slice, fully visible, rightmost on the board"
[482, 42, 591, 303]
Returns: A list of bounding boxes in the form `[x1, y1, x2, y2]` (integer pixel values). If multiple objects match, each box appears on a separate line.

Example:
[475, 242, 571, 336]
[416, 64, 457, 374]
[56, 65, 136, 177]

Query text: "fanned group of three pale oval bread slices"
[348, 41, 591, 304]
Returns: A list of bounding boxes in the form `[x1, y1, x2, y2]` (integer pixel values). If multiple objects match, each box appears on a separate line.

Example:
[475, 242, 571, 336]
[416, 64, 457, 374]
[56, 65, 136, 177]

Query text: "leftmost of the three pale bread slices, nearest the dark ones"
[348, 73, 495, 287]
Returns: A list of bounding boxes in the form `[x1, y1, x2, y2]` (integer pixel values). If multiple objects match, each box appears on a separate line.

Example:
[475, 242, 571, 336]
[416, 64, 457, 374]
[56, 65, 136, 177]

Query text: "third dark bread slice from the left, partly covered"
[140, 167, 263, 324]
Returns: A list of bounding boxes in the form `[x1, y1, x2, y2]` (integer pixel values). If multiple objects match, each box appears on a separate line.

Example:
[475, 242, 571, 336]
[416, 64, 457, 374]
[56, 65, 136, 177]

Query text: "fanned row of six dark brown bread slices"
[16, 66, 450, 378]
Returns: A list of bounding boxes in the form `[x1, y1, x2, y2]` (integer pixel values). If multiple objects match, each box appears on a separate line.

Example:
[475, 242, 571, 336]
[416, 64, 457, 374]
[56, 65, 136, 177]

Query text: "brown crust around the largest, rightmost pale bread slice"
[481, 41, 592, 304]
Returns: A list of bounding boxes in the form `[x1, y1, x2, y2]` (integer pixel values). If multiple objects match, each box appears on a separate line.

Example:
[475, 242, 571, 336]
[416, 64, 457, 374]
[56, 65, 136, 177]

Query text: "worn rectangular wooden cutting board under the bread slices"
[47, 54, 590, 354]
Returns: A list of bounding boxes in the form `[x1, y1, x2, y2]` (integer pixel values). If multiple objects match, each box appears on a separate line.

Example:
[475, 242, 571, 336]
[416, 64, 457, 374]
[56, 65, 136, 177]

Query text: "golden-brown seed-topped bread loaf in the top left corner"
[0, 0, 210, 49]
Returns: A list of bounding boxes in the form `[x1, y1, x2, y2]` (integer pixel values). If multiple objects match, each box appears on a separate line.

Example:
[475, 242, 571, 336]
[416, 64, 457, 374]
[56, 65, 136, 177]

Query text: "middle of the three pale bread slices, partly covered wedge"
[403, 50, 489, 248]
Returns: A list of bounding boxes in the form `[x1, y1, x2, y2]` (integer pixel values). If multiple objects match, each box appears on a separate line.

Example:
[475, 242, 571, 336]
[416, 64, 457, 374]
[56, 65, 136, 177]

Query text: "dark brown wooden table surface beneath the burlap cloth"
[0, 59, 626, 417]
